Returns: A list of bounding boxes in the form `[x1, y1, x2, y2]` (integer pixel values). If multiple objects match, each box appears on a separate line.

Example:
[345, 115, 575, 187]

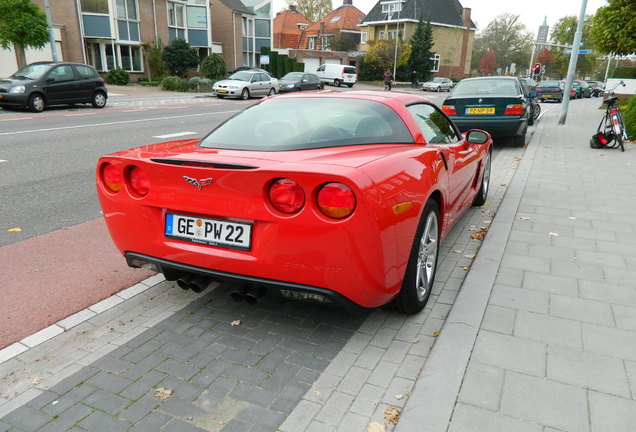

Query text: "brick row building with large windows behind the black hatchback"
[0, 0, 272, 82]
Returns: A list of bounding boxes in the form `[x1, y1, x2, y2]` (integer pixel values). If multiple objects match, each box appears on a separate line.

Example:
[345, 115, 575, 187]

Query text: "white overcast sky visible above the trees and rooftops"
[274, 0, 607, 34]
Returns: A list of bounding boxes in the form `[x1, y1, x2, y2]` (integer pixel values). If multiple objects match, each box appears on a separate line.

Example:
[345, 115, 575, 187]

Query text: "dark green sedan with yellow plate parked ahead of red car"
[442, 76, 533, 146]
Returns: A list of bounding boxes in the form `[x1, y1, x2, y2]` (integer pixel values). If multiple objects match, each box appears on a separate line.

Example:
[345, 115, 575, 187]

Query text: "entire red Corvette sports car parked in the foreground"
[97, 91, 492, 313]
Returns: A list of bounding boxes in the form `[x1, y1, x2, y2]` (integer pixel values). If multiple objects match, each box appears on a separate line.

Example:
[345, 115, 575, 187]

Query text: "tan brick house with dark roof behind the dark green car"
[360, 0, 477, 79]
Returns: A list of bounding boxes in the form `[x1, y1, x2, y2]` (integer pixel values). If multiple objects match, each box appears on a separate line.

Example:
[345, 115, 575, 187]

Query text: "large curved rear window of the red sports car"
[199, 98, 413, 151]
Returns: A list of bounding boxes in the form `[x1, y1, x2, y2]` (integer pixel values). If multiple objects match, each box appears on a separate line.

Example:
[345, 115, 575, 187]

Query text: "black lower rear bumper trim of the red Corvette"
[125, 252, 368, 313]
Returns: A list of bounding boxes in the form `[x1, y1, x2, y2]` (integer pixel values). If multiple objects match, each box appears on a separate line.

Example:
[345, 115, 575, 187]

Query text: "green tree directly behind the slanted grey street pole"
[550, 16, 599, 77]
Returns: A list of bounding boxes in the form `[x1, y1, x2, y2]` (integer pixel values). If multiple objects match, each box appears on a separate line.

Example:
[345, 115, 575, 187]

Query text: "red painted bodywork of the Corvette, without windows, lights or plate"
[97, 92, 491, 307]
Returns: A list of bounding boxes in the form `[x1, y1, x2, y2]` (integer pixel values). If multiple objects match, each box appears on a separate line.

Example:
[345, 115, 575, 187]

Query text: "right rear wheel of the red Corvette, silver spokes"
[391, 199, 439, 314]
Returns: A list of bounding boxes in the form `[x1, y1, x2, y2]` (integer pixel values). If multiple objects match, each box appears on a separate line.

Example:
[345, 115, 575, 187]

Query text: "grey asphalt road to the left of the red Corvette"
[0, 99, 247, 246]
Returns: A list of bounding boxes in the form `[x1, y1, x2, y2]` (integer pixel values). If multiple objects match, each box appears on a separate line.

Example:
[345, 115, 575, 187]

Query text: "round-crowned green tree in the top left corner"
[0, 0, 49, 69]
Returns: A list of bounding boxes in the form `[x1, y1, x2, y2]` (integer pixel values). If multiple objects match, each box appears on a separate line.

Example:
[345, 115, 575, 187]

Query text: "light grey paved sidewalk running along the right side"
[397, 99, 636, 432]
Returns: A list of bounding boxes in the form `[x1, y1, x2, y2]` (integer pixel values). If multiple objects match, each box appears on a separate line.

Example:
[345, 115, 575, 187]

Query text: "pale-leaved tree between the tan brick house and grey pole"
[472, 13, 534, 75]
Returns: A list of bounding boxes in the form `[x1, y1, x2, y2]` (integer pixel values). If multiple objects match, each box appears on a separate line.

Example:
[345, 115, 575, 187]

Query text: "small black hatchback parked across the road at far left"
[0, 62, 108, 112]
